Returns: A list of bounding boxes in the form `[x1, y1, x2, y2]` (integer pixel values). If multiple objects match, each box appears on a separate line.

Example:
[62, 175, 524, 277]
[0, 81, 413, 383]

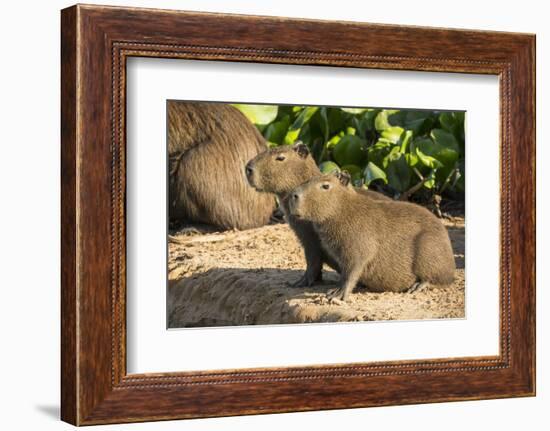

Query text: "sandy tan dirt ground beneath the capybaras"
[168, 217, 464, 328]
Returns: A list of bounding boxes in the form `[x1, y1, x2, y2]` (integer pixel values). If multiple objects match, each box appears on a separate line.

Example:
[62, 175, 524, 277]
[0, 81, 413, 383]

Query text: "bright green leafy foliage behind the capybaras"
[234, 105, 464, 197]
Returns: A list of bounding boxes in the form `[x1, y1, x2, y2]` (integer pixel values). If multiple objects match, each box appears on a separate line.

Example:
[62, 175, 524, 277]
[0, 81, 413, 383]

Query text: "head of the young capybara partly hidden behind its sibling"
[245, 141, 320, 194]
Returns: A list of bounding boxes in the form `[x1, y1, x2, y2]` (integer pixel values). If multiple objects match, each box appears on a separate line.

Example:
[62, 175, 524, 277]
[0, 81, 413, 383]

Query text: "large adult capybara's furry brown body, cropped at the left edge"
[167, 101, 276, 229]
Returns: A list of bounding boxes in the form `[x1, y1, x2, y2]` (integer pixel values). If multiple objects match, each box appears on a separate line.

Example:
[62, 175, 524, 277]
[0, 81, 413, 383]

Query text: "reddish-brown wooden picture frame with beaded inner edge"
[61, 5, 535, 425]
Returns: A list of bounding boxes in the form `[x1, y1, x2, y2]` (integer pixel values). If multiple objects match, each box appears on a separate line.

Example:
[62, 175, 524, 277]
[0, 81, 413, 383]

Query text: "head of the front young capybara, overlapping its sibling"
[289, 171, 356, 223]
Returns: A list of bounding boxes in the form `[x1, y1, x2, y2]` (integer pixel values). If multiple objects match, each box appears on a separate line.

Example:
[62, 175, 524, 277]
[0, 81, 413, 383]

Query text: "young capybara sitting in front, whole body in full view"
[289, 173, 455, 301]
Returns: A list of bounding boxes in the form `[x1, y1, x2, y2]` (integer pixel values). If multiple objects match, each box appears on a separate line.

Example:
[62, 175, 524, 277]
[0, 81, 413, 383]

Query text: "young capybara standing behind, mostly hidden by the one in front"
[245, 141, 390, 287]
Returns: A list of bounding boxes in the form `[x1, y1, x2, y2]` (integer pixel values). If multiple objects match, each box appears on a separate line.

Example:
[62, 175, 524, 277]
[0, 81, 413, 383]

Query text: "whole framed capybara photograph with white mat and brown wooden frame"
[61, 5, 535, 425]
